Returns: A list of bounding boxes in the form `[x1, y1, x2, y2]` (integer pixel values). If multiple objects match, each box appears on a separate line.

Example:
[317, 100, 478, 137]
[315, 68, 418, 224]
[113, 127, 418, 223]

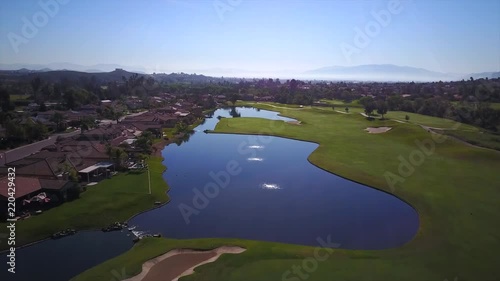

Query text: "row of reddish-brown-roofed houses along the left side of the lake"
[0, 101, 201, 217]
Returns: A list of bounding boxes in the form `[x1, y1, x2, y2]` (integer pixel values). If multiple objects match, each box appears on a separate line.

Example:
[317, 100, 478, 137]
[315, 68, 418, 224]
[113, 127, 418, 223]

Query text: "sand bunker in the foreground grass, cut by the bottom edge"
[126, 246, 246, 281]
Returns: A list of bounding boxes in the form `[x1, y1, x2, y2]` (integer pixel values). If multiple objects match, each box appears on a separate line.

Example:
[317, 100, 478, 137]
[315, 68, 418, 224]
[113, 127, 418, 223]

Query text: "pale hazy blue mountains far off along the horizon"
[0, 63, 500, 82]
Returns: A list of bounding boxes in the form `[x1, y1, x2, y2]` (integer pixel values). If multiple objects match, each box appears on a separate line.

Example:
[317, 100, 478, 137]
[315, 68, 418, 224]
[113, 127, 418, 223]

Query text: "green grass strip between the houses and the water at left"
[0, 157, 169, 249]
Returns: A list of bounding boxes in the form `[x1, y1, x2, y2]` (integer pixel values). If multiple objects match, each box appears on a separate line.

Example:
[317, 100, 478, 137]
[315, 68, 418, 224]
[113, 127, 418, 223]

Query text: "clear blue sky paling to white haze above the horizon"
[0, 0, 500, 73]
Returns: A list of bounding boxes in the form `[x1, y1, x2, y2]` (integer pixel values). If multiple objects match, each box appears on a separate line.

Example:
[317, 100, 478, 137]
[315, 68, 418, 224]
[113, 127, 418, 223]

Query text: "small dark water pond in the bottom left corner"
[0, 231, 133, 281]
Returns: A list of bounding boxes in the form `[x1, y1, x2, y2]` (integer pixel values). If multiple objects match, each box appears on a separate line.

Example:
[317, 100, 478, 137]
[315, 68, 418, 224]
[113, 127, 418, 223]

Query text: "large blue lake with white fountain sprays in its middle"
[131, 108, 418, 249]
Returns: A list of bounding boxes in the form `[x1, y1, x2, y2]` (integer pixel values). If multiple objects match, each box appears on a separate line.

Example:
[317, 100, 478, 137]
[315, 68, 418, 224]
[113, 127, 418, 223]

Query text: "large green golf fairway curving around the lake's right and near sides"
[75, 104, 500, 281]
